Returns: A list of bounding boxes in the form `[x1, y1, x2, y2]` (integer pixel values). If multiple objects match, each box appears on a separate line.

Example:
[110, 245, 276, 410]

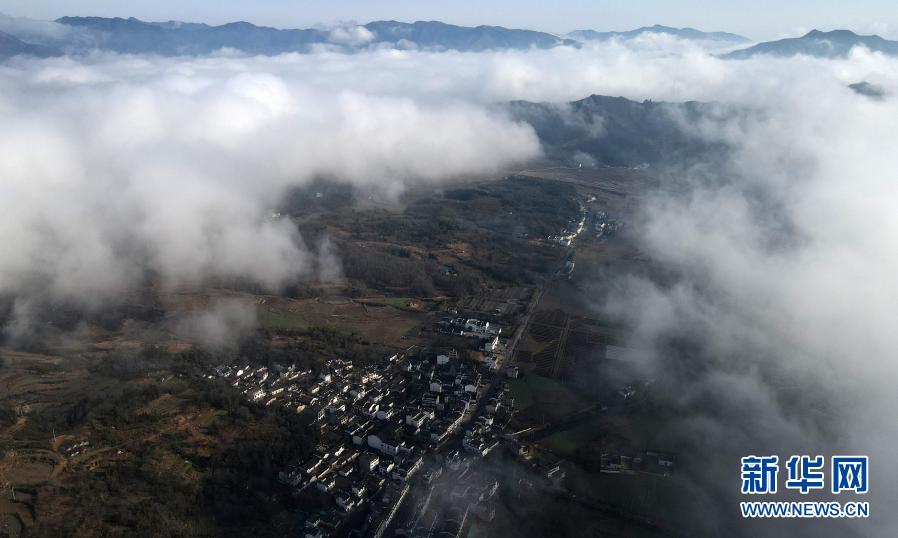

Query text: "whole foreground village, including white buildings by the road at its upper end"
[200, 312, 519, 538]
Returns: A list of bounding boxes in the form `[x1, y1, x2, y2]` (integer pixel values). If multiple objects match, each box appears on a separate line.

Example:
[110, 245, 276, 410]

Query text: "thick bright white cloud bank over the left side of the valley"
[0, 51, 540, 314]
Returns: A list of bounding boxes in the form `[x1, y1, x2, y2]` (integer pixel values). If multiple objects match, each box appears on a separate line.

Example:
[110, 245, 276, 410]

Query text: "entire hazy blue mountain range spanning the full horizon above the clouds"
[0, 16, 898, 60]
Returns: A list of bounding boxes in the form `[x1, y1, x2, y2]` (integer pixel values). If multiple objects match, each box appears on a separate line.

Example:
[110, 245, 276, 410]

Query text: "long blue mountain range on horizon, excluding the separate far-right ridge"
[0, 17, 748, 57]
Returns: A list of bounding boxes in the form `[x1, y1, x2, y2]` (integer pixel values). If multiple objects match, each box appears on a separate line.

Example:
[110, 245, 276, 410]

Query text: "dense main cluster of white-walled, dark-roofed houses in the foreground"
[209, 350, 507, 537]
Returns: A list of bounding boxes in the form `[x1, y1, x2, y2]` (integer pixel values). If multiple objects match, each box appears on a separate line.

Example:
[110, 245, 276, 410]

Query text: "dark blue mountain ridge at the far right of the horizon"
[723, 30, 898, 60]
